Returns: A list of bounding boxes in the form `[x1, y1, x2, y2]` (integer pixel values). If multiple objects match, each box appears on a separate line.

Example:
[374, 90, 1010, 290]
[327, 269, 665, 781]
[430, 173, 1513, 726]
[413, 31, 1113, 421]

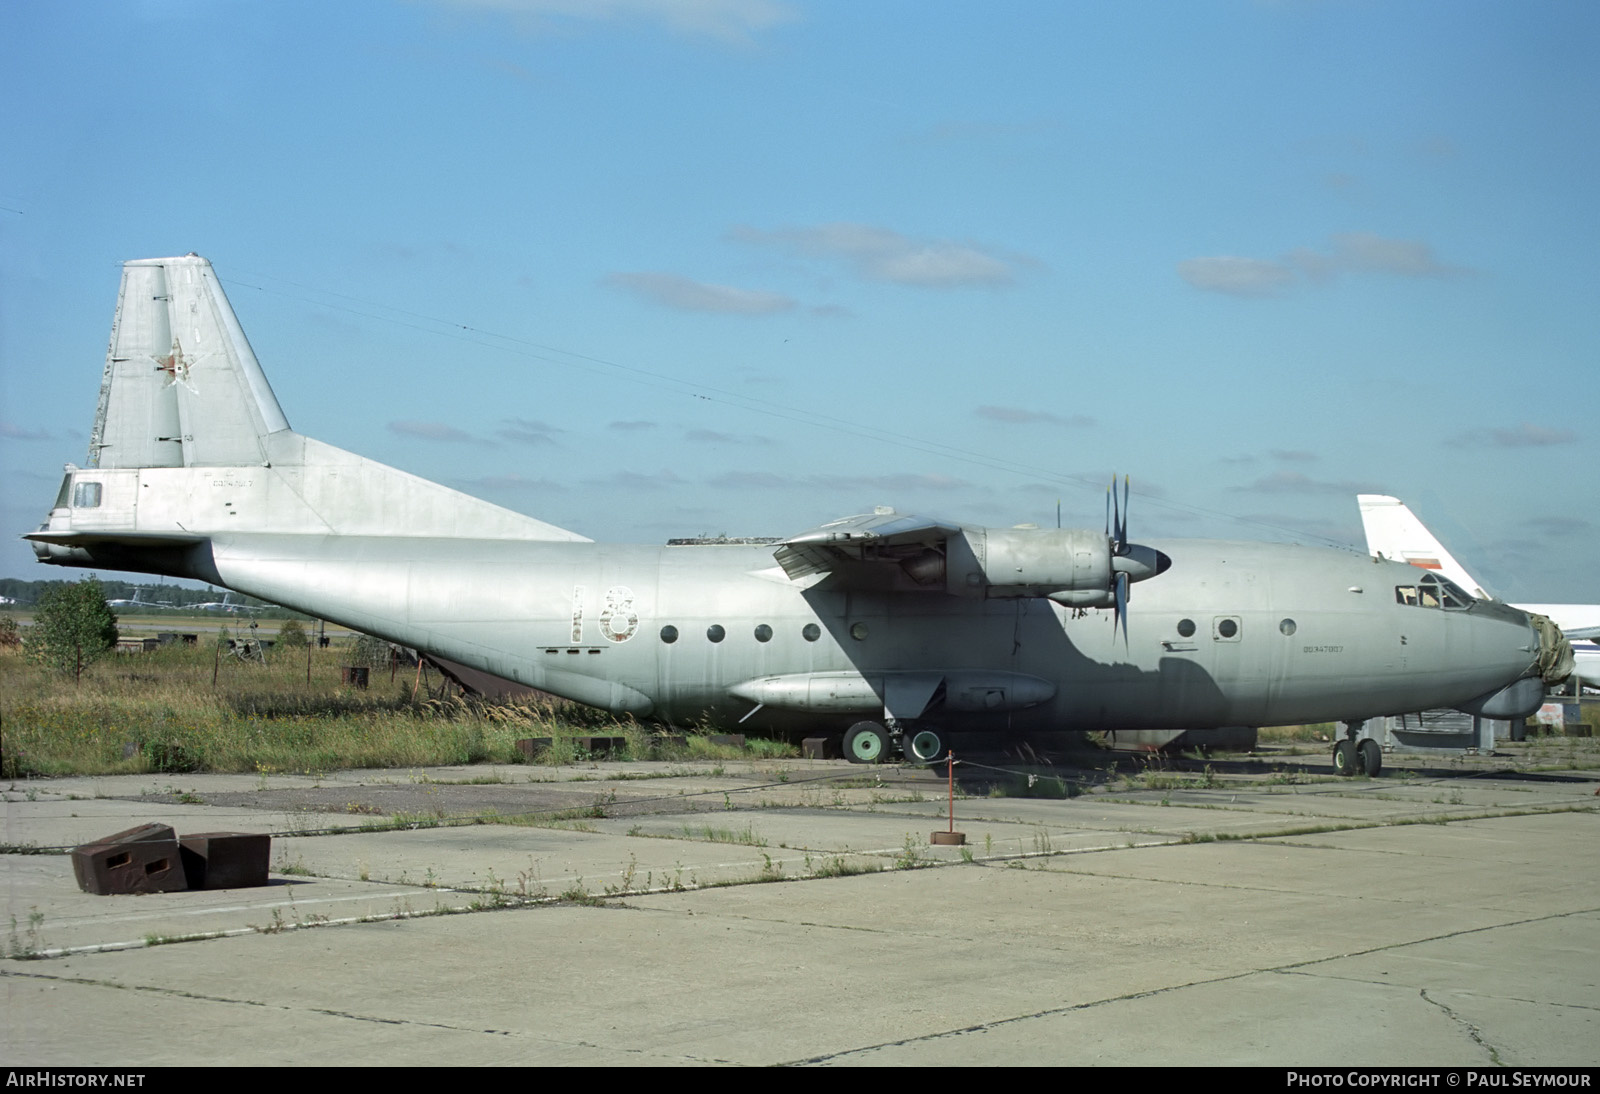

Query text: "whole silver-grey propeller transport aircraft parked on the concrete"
[27, 254, 1570, 774]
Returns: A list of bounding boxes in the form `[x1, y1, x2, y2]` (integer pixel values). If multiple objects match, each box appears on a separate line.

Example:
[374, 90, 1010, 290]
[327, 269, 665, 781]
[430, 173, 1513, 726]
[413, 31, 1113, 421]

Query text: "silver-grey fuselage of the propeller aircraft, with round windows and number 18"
[131, 534, 1538, 731]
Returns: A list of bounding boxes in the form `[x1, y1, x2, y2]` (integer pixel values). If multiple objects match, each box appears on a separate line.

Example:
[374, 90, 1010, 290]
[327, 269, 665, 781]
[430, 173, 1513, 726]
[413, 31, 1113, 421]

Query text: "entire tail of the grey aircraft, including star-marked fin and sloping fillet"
[27, 254, 584, 584]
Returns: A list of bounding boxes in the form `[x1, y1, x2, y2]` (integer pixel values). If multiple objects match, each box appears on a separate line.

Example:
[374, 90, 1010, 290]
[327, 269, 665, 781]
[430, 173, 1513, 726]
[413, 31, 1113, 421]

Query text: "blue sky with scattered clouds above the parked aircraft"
[0, 0, 1600, 601]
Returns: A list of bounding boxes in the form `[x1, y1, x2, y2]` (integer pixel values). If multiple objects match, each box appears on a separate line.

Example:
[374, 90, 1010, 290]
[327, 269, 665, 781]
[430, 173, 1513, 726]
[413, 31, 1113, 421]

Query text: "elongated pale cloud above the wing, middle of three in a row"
[728, 222, 1038, 288]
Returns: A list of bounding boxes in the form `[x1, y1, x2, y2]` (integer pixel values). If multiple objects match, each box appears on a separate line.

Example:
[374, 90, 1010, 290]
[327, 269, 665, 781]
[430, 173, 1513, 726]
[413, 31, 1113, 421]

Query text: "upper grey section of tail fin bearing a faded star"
[90, 254, 290, 469]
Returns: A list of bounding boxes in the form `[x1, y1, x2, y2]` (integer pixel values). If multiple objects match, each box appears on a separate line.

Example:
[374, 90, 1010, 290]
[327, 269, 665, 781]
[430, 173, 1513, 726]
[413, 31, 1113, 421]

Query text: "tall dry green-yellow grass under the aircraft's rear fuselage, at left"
[0, 646, 797, 782]
